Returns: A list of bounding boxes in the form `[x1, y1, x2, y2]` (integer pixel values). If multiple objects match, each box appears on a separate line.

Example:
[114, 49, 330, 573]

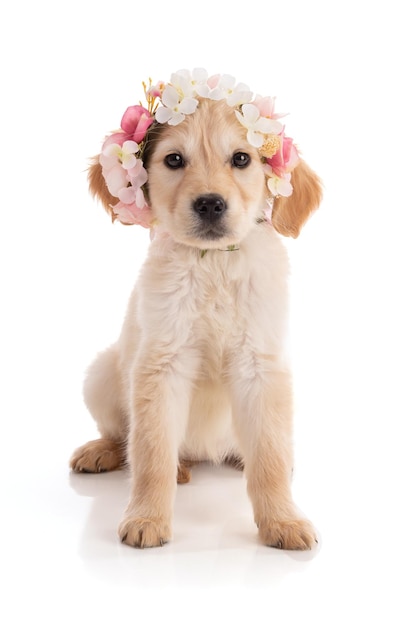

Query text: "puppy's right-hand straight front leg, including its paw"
[233, 358, 316, 550]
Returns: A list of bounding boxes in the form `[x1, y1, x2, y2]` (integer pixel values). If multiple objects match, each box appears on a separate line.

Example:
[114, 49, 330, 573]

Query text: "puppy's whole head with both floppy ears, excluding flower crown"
[89, 73, 321, 249]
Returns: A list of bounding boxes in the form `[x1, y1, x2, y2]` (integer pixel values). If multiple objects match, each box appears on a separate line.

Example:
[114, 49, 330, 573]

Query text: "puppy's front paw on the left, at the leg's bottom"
[118, 517, 171, 548]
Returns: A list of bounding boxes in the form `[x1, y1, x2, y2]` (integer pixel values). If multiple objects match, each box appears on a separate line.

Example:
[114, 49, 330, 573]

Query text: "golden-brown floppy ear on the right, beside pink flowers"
[272, 160, 322, 238]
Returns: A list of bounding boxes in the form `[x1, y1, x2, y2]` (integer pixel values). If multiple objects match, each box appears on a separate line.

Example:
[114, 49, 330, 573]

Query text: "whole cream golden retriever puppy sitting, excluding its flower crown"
[71, 74, 321, 550]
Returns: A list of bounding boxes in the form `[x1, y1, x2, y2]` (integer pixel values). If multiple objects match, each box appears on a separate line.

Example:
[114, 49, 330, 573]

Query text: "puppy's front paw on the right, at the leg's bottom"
[258, 520, 317, 550]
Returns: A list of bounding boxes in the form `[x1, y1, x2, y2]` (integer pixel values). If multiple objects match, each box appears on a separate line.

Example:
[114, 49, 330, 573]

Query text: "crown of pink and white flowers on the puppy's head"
[99, 69, 299, 228]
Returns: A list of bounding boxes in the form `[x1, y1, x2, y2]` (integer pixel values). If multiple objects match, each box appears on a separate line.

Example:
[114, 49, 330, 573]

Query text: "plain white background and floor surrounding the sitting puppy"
[0, 0, 404, 626]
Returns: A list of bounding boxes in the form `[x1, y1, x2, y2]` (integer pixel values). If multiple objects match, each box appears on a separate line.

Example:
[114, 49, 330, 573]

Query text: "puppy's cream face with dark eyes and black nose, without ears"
[145, 100, 268, 249]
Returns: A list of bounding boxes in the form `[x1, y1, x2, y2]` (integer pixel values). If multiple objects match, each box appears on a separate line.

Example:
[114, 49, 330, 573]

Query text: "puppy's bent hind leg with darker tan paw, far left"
[70, 346, 127, 473]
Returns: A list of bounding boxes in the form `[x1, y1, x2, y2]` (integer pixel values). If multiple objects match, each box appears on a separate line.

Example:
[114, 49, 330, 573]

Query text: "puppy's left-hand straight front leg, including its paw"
[119, 349, 191, 548]
